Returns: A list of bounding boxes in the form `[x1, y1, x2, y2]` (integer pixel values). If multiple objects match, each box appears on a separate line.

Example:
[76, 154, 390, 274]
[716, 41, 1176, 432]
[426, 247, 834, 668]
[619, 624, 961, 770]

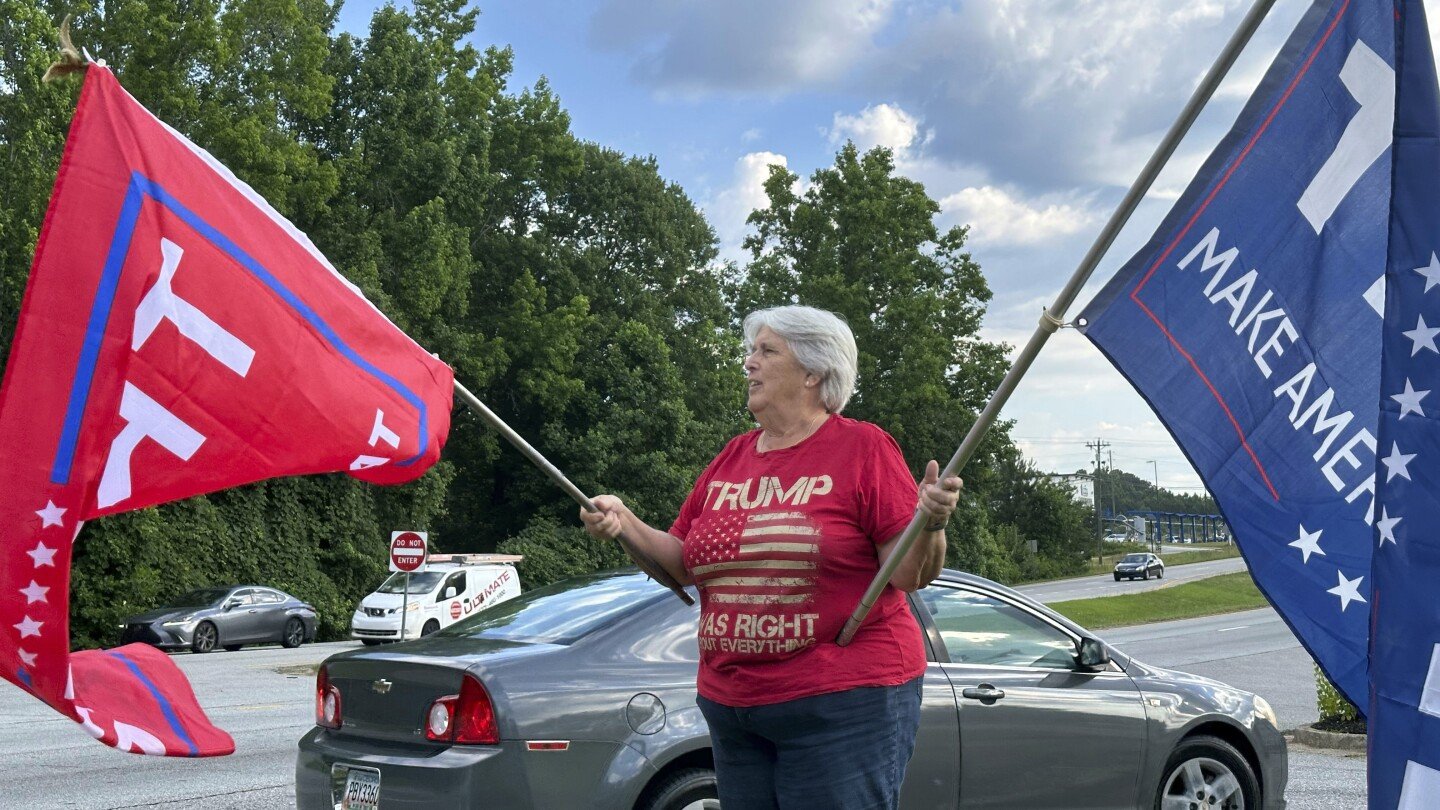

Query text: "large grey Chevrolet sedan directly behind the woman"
[295, 571, 1287, 810]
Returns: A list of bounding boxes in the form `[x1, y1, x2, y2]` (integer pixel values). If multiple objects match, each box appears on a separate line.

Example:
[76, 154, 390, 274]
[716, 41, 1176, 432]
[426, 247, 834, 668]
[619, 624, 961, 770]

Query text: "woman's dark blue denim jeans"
[696, 677, 923, 810]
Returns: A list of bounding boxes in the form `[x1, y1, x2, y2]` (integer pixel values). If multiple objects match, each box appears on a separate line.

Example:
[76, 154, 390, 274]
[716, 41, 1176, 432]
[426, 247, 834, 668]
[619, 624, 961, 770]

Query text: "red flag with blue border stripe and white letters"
[0, 65, 452, 757]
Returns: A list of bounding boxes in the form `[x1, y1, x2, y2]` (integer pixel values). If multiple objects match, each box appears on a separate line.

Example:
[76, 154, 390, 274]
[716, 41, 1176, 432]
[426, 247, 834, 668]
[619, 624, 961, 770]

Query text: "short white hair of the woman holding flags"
[742, 306, 858, 414]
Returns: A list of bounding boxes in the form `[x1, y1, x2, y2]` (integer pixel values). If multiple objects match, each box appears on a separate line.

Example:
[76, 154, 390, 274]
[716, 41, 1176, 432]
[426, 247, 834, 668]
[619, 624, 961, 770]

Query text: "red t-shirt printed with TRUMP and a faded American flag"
[670, 415, 926, 706]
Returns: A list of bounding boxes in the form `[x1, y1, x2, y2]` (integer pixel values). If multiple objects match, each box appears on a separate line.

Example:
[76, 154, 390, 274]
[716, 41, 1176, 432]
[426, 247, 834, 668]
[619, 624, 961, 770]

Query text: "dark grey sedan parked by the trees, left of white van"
[120, 585, 315, 653]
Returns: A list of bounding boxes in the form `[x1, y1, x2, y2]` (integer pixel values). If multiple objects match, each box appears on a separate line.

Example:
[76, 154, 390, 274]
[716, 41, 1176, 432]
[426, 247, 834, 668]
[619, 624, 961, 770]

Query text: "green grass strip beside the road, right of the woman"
[1050, 571, 1269, 630]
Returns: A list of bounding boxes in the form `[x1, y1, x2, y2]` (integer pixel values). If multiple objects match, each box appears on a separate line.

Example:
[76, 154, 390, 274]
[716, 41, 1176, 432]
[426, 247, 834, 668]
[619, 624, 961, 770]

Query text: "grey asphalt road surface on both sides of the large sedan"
[0, 561, 1365, 810]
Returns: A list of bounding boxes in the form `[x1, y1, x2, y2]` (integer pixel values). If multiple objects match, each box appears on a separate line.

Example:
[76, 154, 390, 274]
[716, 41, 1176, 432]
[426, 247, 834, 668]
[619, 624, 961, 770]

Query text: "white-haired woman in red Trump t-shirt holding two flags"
[580, 307, 960, 810]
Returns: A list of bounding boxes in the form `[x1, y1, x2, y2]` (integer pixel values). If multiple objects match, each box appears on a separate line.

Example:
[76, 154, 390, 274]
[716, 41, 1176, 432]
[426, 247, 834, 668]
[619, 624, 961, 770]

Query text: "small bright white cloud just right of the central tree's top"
[940, 186, 1099, 246]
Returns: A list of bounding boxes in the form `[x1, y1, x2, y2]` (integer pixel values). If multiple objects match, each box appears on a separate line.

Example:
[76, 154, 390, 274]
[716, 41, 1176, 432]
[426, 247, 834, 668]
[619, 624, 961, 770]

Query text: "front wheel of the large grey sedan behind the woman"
[1155, 736, 1260, 810]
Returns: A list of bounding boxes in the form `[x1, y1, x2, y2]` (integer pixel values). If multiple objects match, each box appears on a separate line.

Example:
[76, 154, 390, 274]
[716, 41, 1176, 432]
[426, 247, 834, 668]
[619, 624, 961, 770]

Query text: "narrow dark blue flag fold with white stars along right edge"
[1369, 1, 1440, 810]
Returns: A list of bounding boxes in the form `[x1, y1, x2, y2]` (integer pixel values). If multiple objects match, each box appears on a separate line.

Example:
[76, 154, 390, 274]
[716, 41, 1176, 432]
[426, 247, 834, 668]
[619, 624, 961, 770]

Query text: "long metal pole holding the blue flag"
[835, 0, 1274, 647]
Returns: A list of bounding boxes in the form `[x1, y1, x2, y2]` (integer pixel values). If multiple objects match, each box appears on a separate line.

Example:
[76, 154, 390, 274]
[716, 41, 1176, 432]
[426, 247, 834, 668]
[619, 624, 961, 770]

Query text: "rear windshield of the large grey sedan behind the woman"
[438, 574, 667, 644]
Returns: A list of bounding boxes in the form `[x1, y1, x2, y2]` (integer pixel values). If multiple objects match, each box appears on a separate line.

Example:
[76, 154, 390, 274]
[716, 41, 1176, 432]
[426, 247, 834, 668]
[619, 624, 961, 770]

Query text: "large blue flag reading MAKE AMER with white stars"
[1081, 0, 1440, 810]
